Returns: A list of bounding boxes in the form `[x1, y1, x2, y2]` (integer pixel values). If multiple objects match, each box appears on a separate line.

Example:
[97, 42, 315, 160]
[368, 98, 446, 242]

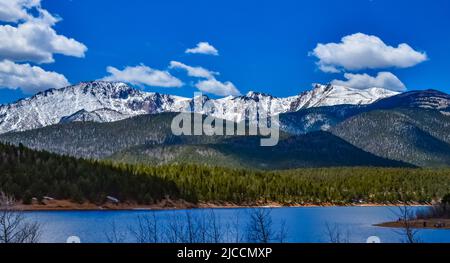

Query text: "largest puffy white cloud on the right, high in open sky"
[310, 33, 427, 73]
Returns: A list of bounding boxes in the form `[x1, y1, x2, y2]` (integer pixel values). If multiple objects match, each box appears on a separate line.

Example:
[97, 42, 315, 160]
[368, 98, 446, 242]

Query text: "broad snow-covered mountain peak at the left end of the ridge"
[0, 82, 188, 133]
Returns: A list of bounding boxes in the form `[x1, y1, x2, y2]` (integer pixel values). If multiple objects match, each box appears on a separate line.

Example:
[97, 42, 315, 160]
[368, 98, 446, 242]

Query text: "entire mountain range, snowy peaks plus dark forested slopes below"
[0, 82, 450, 170]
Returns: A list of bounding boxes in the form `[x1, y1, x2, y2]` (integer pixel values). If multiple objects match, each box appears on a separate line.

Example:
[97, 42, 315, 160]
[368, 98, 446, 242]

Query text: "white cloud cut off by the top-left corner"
[0, 0, 41, 23]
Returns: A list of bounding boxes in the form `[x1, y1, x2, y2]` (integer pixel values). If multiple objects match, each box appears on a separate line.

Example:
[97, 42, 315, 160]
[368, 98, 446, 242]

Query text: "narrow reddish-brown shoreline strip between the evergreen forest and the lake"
[14, 200, 431, 212]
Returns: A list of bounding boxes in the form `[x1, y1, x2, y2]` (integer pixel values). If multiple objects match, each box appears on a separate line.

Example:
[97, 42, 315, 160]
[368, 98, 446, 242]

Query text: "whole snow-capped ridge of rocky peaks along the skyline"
[0, 81, 398, 134]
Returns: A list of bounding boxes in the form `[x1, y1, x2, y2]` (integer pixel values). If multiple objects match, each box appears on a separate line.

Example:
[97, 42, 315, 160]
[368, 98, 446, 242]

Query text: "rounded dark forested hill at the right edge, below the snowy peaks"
[331, 108, 450, 167]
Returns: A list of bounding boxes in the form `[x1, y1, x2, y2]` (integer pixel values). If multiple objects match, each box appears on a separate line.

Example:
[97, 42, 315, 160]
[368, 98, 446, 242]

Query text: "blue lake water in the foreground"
[23, 207, 450, 243]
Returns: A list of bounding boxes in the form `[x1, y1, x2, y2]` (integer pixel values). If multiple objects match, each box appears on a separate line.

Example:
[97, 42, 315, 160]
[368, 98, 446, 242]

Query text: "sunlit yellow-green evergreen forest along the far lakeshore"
[137, 165, 450, 205]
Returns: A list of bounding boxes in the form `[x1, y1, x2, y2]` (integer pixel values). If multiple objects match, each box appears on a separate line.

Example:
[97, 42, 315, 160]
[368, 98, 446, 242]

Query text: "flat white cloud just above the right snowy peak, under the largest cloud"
[331, 72, 406, 91]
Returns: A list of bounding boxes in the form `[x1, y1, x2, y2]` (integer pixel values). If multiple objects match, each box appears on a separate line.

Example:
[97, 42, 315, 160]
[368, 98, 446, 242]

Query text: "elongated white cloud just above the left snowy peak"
[103, 65, 183, 87]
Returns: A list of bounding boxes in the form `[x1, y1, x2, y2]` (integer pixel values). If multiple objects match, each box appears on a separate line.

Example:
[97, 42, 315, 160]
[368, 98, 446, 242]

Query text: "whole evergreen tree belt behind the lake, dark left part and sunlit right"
[0, 144, 450, 205]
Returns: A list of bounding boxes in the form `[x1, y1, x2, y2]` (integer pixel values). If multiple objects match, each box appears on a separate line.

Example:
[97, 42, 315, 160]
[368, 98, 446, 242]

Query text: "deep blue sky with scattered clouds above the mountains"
[0, 0, 450, 103]
